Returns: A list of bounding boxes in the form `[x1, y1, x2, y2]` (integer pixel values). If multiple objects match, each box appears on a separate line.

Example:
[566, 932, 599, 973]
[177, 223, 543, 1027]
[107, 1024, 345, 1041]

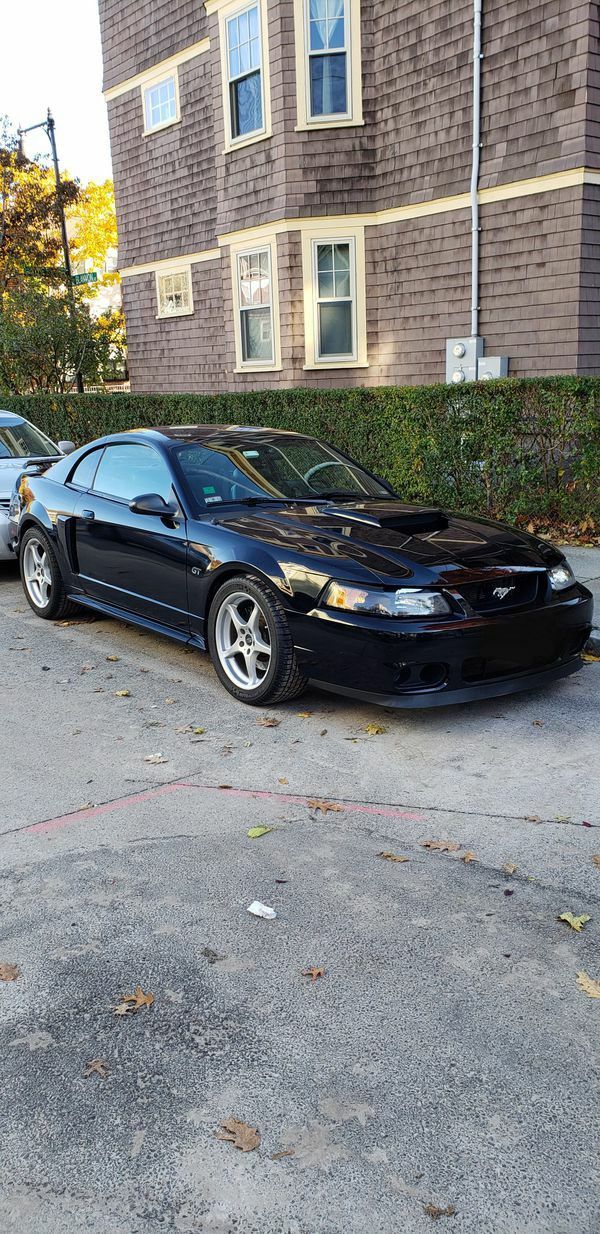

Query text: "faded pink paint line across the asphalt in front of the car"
[23, 780, 423, 833]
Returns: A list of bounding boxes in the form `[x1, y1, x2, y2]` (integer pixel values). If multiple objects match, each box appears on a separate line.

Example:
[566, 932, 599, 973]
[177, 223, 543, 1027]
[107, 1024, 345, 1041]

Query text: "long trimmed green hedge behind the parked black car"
[4, 376, 600, 531]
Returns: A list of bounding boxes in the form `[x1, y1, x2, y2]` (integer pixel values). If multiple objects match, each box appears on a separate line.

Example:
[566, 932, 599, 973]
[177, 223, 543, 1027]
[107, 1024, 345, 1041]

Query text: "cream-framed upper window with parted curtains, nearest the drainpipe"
[294, 0, 363, 128]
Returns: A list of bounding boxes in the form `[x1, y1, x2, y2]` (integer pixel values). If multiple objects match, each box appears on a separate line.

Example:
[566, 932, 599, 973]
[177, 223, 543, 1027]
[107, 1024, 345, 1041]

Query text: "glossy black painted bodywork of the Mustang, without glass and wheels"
[15, 426, 593, 707]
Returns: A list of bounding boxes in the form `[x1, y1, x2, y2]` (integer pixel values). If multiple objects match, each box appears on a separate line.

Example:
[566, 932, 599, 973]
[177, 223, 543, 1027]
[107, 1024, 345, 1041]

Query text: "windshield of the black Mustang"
[174, 434, 390, 508]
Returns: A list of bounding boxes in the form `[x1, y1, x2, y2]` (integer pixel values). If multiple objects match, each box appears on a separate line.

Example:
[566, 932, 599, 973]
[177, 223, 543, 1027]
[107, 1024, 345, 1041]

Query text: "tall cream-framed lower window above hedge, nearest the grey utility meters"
[302, 226, 368, 369]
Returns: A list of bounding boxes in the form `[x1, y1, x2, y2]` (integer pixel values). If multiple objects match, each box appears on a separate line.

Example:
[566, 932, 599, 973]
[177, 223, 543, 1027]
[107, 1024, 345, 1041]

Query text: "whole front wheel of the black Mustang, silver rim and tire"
[209, 578, 306, 706]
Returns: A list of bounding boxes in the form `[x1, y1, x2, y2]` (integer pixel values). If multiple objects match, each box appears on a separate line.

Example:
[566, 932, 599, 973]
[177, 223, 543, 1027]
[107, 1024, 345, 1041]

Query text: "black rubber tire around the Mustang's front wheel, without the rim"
[207, 575, 307, 707]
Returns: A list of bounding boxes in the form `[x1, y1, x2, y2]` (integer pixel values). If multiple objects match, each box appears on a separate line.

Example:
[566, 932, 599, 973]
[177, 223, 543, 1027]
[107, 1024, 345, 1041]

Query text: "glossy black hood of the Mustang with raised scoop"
[215, 500, 560, 582]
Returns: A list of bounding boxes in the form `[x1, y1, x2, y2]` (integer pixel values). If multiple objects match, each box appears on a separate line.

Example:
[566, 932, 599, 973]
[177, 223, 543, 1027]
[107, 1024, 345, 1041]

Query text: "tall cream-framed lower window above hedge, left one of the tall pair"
[232, 243, 281, 371]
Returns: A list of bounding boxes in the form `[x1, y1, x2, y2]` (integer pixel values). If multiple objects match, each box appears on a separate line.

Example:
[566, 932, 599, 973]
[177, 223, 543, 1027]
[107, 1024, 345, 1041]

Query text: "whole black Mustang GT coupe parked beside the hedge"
[11, 424, 593, 707]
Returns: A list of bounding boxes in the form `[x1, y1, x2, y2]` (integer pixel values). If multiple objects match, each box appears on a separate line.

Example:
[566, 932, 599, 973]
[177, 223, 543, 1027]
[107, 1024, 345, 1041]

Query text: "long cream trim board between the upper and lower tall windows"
[120, 167, 600, 278]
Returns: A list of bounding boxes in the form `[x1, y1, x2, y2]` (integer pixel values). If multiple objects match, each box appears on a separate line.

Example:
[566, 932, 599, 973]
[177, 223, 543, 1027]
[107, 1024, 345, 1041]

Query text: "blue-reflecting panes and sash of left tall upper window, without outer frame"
[227, 5, 264, 141]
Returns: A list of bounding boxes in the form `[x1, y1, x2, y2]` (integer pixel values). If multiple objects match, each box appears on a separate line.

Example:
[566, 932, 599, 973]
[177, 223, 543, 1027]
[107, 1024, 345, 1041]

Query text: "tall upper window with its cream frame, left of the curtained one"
[205, 0, 272, 152]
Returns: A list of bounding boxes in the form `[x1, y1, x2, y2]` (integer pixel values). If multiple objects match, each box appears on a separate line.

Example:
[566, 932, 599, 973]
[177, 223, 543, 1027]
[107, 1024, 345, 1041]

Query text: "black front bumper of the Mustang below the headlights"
[289, 584, 593, 708]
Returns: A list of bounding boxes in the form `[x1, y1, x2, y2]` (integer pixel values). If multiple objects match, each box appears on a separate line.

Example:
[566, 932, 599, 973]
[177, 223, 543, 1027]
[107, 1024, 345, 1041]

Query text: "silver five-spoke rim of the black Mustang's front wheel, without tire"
[215, 591, 272, 690]
